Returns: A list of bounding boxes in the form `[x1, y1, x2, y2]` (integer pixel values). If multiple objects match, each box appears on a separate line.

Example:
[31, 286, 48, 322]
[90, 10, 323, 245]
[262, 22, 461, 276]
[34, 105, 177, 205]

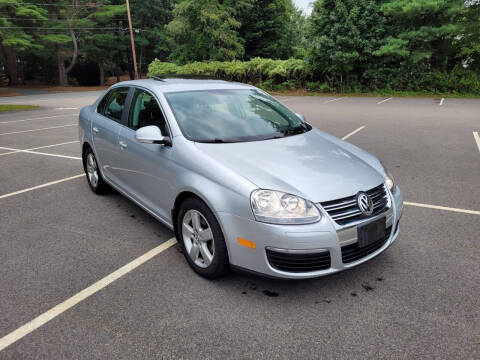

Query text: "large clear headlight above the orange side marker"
[250, 189, 320, 224]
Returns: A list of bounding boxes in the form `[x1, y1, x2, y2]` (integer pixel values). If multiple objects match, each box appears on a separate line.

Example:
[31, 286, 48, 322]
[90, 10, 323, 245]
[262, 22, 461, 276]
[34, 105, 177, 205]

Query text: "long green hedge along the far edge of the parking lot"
[148, 58, 480, 95]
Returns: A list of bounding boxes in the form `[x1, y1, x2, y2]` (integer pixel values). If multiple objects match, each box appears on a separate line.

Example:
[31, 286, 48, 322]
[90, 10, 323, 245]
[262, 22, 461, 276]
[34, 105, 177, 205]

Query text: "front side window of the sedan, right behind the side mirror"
[128, 89, 168, 135]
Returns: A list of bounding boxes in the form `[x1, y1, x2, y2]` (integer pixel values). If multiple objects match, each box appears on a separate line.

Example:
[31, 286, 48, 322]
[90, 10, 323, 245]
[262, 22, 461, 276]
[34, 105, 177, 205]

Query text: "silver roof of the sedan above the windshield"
[114, 78, 254, 93]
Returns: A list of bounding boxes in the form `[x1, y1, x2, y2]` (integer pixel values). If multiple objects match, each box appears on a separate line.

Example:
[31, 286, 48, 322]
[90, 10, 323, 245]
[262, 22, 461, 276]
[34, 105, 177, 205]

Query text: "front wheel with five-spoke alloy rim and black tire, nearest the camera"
[177, 198, 229, 279]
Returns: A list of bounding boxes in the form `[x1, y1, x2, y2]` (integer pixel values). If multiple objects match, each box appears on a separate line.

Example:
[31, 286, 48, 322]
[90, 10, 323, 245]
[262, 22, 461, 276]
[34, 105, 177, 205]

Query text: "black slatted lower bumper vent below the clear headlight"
[266, 249, 330, 272]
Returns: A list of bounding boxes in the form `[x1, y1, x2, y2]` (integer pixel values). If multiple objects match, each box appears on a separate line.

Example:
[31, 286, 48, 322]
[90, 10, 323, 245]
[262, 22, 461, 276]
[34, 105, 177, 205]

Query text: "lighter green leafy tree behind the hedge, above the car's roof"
[167, 0, 243, 63]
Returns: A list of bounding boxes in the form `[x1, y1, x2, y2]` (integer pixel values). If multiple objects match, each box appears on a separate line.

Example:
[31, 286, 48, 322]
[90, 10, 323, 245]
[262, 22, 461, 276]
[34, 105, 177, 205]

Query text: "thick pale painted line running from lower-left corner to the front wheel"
[0, 237, 177, 351]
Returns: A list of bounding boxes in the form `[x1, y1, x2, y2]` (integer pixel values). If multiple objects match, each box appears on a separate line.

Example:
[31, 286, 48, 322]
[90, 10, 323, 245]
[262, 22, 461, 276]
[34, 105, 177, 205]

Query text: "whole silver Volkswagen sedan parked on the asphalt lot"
[79, 79, 403, 279]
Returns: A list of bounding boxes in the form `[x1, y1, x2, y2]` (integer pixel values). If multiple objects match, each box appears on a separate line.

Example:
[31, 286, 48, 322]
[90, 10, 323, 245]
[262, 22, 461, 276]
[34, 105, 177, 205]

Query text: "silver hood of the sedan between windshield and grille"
[196, 129, 384, 202]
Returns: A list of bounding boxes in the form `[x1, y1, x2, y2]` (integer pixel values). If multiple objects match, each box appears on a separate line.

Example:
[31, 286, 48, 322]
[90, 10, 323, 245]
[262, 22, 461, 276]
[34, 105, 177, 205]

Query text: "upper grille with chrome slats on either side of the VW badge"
[321, 184, 388, 225]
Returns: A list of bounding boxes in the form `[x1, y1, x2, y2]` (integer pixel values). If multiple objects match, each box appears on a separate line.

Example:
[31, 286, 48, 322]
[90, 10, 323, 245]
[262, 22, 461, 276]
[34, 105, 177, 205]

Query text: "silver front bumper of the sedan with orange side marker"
[217, 187, 403, 279]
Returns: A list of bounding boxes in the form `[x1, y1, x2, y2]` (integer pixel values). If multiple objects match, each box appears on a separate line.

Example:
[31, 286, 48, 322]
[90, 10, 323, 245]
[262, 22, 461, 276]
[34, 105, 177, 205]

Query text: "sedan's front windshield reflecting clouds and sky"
[165, 89, 311, 143]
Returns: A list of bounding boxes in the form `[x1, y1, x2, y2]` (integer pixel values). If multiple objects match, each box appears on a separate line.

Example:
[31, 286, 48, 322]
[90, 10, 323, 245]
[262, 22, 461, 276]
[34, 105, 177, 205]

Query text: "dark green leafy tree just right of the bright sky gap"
[309, 0, 385, 86]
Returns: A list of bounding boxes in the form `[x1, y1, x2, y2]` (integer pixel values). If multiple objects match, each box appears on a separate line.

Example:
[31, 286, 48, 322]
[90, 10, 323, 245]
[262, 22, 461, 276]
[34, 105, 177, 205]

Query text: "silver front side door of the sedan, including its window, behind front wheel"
[119, 88, 175, 221]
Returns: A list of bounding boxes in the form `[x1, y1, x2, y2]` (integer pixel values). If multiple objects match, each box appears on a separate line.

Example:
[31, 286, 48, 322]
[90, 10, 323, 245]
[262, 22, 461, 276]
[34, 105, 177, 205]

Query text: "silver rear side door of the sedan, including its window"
[92, 87, 130, 184]
